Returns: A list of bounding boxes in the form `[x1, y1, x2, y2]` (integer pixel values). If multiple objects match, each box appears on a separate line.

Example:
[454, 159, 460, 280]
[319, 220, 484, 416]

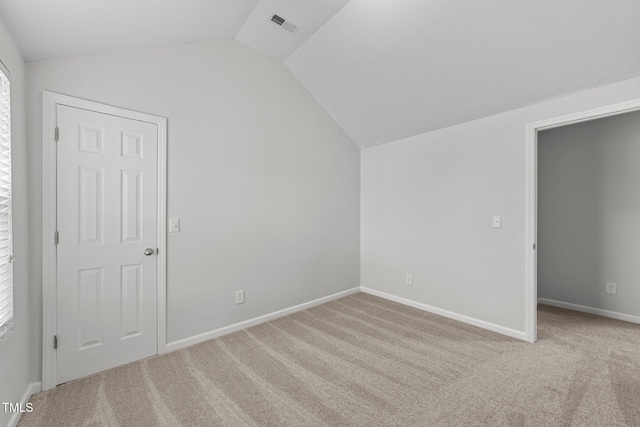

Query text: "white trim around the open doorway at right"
[524, 98, 640, 342]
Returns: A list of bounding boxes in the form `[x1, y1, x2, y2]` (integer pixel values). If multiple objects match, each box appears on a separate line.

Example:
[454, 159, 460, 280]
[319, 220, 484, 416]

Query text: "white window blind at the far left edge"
[0, 63, 13, 340]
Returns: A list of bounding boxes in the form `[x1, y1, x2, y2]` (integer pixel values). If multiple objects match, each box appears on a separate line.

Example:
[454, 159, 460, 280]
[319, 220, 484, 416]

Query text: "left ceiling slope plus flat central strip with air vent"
[0, 0, 349, 61]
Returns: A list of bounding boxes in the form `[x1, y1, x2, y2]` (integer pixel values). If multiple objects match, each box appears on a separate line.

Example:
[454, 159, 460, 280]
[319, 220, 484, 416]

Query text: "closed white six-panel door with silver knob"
[56, 105, 158, 384]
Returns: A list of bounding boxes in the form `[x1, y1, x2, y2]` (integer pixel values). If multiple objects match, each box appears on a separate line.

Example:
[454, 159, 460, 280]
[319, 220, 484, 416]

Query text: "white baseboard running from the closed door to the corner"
[166, 287, 360, 352]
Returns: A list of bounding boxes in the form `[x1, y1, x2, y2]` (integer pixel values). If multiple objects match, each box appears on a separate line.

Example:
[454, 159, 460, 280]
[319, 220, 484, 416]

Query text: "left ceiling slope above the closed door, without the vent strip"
[0, 0, 260, 61]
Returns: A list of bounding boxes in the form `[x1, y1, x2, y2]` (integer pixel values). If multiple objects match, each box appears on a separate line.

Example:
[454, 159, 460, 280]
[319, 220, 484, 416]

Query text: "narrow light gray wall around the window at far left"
[0, 15, 40, 426]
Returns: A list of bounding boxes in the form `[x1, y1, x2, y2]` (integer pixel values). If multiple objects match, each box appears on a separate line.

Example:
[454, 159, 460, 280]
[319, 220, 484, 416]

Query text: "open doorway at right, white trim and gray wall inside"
[525, 100, 640, 342]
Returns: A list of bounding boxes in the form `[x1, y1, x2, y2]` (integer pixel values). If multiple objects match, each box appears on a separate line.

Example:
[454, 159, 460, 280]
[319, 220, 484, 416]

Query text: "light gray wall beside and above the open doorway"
[361, 78, 640, 332]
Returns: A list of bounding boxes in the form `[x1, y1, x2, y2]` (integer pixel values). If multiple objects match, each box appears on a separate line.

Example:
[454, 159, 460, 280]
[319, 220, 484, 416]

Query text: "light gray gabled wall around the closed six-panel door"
[27, 41, 360, 342]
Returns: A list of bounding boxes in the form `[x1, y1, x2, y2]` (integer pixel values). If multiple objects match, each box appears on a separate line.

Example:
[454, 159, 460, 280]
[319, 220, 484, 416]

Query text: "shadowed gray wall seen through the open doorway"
[538, 112, 640, 316]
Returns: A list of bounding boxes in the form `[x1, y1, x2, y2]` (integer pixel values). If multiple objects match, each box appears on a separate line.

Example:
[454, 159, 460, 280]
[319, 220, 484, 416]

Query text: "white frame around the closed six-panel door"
[42, 91, 167, 391]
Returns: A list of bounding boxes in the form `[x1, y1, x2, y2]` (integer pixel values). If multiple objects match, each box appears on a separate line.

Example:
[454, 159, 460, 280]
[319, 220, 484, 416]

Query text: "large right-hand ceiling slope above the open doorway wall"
[285, 0, 640, 147]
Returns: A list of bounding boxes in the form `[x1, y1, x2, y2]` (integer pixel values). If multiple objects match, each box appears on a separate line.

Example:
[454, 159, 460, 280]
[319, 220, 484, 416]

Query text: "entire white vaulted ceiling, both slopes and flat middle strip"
[0, 0, 640, 147]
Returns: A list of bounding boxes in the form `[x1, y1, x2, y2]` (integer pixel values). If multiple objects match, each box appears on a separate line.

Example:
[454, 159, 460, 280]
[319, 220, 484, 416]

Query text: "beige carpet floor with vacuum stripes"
[19, 293, 640, 427]
